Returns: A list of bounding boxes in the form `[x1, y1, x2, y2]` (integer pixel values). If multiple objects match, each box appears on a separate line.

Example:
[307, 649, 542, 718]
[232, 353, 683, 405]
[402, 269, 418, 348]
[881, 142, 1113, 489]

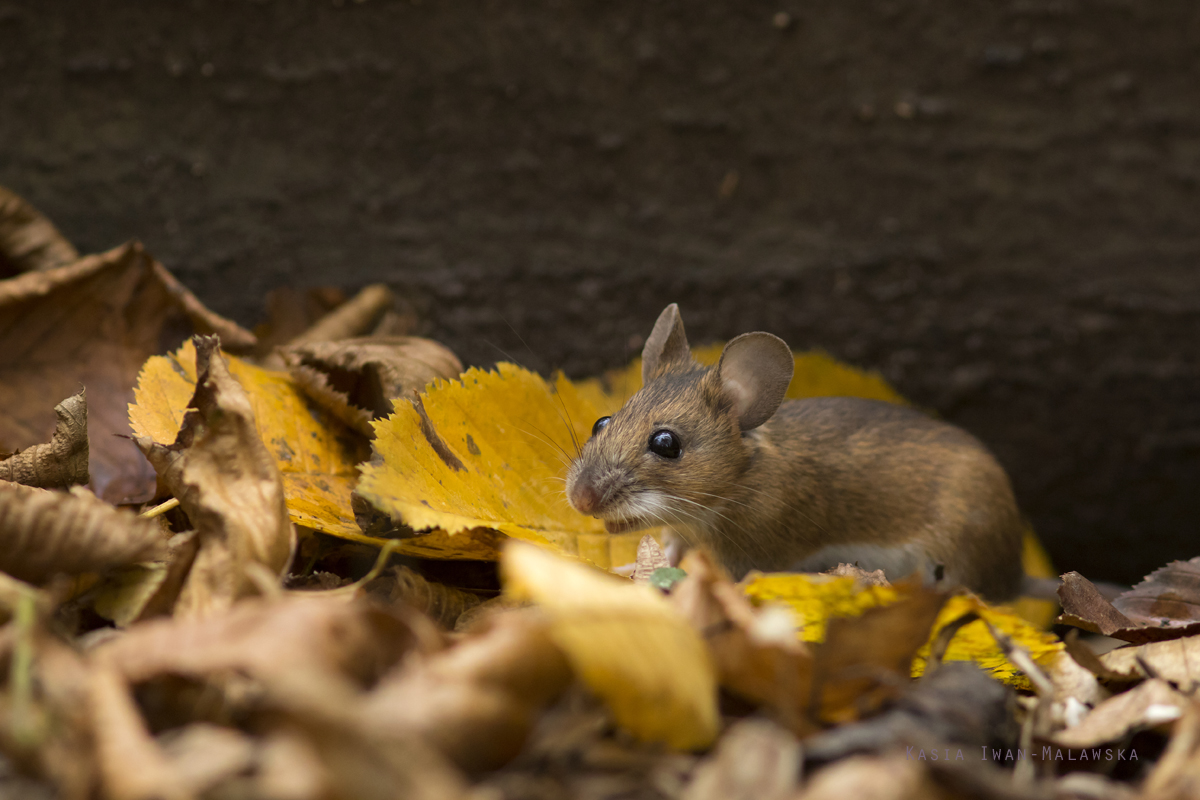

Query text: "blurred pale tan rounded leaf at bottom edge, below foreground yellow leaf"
[683, 720, 804, 800]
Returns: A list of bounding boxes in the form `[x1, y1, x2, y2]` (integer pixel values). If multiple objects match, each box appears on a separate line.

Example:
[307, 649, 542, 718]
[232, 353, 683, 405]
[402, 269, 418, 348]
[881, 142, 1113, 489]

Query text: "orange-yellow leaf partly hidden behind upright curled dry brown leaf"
[130, 341, 362, 542]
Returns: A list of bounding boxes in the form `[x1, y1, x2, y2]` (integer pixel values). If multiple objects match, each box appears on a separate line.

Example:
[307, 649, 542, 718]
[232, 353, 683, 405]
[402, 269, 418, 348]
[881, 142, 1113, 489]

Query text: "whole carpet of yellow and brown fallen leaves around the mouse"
[0, 184, 1200, 800]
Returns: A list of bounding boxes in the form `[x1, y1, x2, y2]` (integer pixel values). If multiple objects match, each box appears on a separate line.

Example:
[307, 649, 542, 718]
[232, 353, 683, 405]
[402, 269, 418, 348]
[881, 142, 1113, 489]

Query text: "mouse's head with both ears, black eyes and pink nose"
[566, 303, 793, 533]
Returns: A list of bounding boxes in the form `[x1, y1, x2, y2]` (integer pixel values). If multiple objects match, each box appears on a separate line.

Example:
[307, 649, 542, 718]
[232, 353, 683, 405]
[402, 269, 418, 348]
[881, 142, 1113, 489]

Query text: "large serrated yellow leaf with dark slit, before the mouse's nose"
[358, 363, 641, 567]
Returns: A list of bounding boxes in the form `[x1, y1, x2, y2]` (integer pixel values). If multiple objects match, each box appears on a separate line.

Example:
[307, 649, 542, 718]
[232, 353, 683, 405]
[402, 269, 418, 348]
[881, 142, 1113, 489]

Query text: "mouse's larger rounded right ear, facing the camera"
[715, 332, 796, 431]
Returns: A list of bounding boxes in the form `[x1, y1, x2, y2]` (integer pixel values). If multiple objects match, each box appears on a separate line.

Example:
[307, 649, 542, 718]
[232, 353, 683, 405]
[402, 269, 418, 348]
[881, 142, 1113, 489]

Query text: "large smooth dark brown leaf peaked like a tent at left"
[0, 242, 254, 503]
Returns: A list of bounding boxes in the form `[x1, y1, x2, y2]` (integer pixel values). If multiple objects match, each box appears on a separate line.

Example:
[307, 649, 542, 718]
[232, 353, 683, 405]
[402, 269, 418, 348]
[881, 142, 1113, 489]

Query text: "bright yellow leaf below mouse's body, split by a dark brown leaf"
[744, 573, 1063, 687]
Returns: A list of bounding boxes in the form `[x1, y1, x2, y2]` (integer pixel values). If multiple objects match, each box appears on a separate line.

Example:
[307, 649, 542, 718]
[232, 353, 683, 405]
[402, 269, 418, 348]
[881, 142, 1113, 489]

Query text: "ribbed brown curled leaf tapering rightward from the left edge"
[0, 483, 163, 583]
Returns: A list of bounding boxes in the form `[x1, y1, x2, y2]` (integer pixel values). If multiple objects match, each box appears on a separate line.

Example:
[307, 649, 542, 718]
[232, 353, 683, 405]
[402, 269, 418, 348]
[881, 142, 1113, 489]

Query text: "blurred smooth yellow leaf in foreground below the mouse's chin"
[502, 542, 719, 750]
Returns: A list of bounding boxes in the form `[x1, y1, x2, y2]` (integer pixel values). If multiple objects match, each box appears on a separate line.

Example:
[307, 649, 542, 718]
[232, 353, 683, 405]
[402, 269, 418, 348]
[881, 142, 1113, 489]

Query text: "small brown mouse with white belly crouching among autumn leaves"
[566, 303, 1022, 601]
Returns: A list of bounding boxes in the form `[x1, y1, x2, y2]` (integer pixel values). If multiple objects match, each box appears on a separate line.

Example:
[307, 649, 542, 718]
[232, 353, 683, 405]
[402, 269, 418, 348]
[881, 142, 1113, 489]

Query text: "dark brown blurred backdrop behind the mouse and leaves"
[0, 0, 1200, 582]
